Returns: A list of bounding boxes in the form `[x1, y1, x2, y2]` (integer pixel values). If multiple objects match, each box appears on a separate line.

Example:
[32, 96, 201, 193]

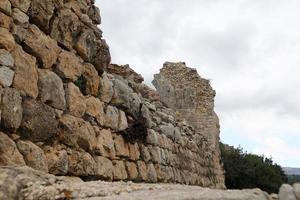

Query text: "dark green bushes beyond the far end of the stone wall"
[220, 143, 287, 193]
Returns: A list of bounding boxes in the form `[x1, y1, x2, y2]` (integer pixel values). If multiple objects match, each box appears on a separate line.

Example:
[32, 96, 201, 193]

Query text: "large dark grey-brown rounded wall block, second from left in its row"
[20, 100, 58, 142]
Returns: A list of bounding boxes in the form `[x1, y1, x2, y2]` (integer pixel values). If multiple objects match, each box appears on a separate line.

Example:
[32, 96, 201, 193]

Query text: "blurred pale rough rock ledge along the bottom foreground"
[0, 167, 271, 200]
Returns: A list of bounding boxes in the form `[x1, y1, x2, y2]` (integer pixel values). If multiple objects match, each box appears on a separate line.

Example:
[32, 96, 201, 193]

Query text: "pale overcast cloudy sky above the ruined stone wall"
[96, 0, 300, 167]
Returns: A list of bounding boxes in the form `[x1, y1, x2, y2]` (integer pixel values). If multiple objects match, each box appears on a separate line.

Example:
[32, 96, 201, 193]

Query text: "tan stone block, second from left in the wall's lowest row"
[17, 140, 48, 172]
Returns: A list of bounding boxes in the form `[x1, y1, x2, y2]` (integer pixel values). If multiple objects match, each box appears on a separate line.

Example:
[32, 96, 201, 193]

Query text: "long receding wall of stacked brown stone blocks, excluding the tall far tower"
[0, 0, 224, 188]
